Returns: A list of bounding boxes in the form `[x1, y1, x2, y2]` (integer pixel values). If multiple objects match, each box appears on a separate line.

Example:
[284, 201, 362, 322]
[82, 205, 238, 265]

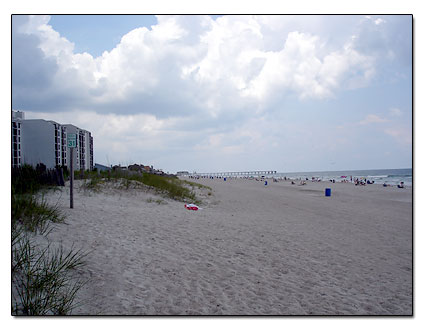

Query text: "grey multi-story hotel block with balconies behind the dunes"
[12, 111, 93, 170]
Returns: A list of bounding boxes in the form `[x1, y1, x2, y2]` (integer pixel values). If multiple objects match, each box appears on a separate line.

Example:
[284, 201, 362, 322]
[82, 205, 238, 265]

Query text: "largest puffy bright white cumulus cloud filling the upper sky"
[13, 16, 375, 117]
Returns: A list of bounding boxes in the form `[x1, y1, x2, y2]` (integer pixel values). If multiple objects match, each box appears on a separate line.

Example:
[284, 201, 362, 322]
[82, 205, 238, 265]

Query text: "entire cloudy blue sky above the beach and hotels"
[12, 14, 413, 173]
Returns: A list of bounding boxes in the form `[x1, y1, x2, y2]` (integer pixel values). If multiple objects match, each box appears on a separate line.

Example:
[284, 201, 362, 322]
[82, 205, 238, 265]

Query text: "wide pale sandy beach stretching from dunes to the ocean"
[37, 179, 413, 315]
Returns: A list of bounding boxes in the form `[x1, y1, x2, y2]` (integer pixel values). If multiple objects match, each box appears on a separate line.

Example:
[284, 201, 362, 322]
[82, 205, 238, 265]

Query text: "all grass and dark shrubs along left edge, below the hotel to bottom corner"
[11, 166, 86, 315]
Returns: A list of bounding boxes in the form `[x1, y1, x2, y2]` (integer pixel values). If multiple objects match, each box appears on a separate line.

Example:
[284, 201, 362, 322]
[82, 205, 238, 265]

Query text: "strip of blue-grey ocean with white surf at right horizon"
[273, 168, 413, 186]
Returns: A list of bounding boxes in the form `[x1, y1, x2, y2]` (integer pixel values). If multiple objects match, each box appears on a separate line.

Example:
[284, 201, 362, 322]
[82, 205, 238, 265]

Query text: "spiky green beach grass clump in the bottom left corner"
[12, 226, 87, 315]
